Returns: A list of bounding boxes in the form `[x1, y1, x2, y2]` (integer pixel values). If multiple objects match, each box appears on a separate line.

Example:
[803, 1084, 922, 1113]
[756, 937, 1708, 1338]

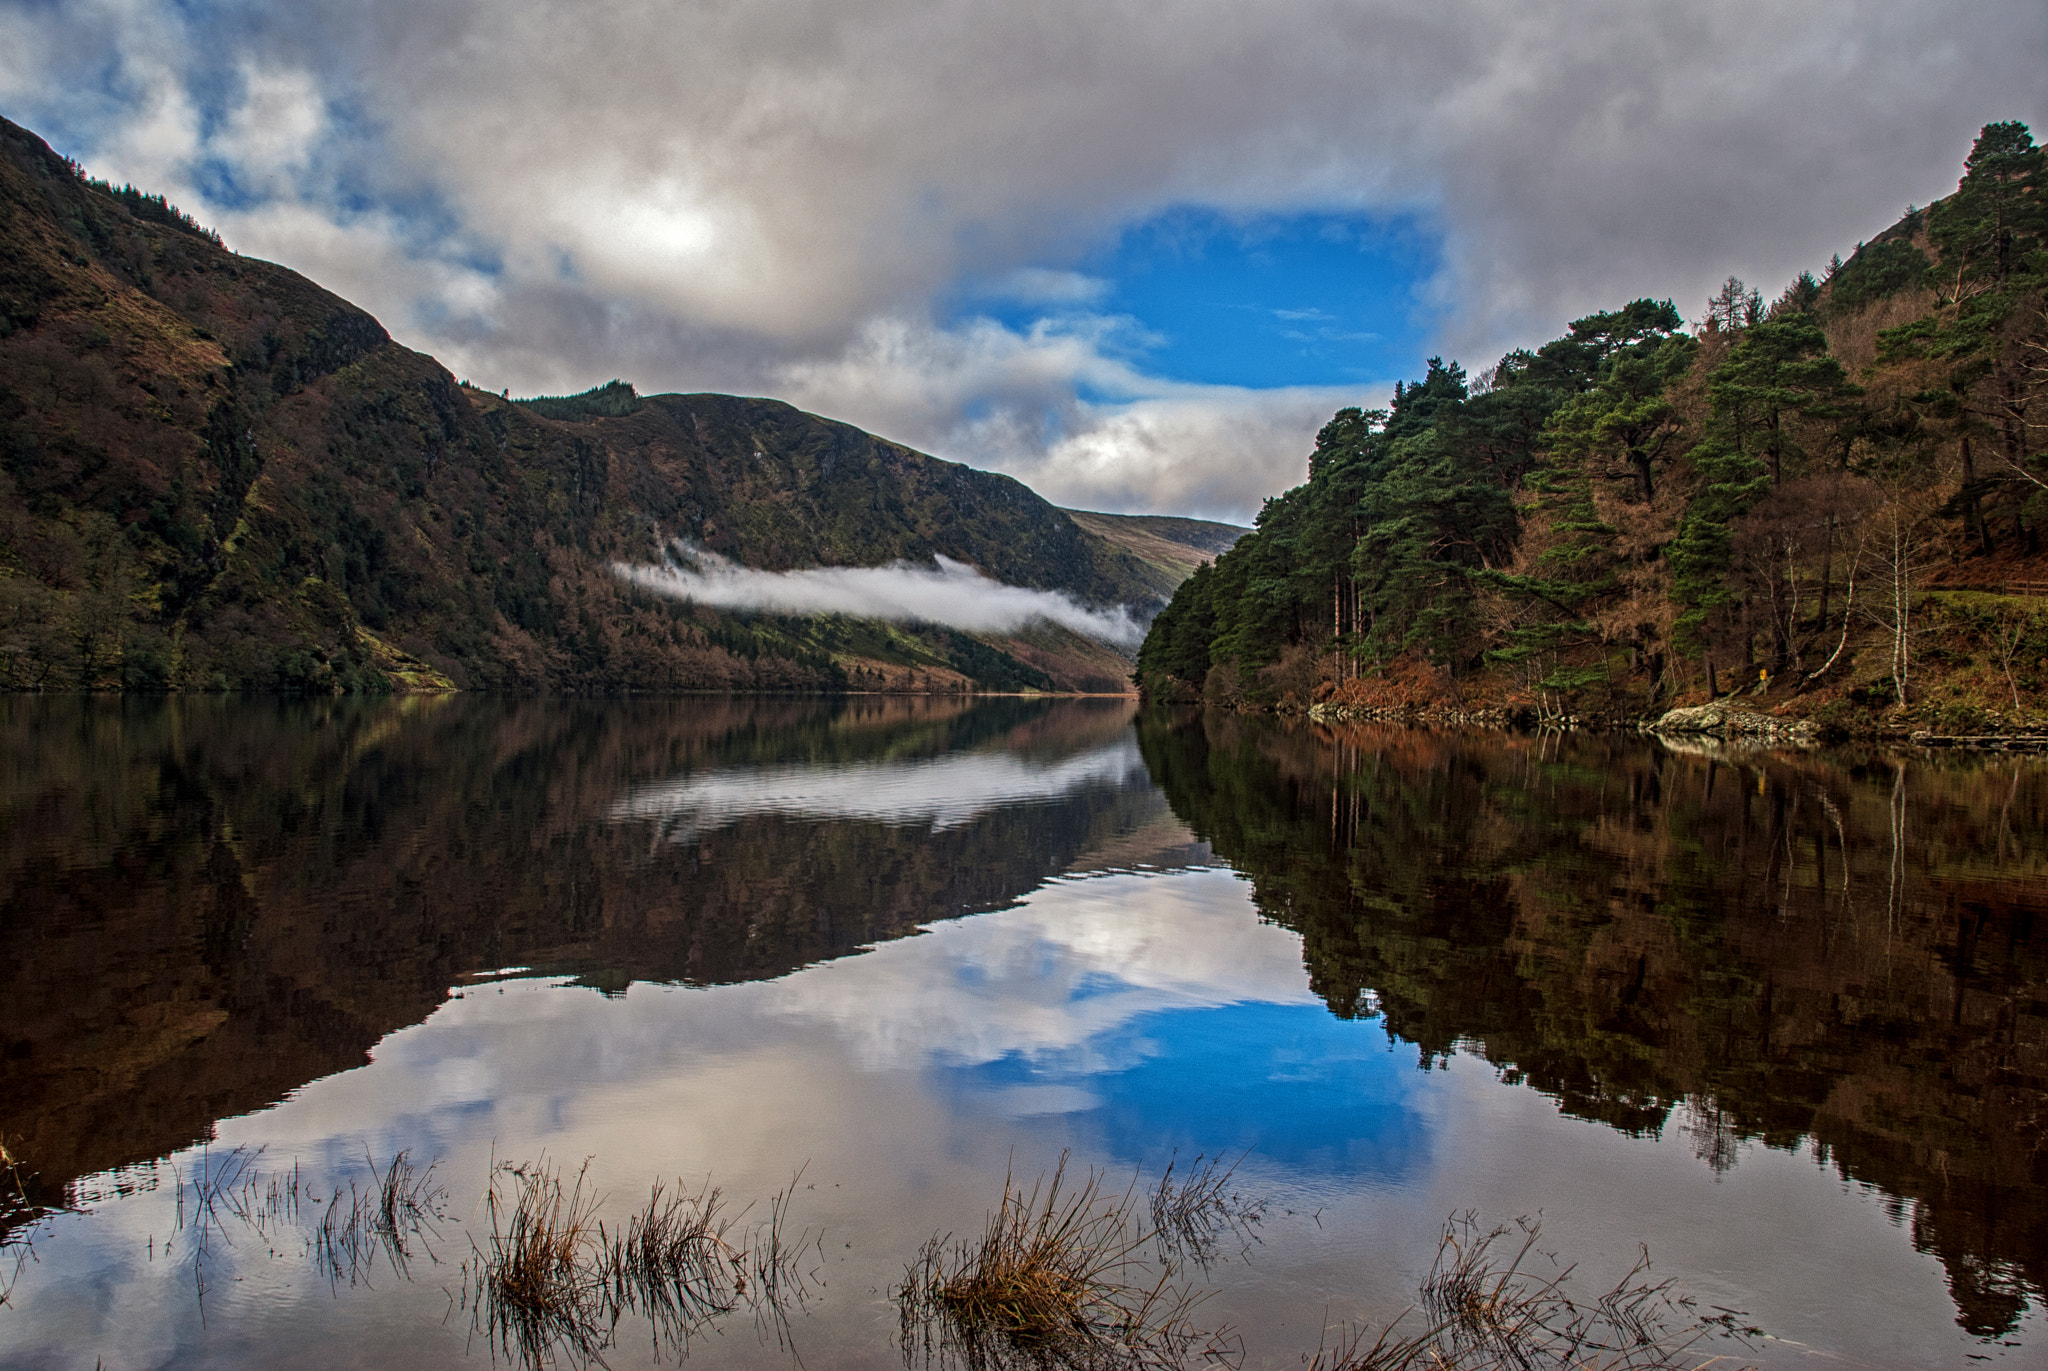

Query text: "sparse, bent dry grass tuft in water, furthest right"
[1307, 1213, 1759, 1371]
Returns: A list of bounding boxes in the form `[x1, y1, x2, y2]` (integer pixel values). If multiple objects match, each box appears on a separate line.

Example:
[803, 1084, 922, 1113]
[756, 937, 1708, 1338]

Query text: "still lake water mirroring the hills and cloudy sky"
[0, 699, 2048, 1369]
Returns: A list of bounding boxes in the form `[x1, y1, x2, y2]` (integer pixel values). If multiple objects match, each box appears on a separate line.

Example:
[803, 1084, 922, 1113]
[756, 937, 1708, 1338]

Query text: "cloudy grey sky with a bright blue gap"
[0, 0, 2048, 521]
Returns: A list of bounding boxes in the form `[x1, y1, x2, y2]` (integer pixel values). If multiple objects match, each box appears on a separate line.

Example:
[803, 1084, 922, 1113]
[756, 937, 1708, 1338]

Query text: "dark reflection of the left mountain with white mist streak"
[0, 697, 1202, 1203]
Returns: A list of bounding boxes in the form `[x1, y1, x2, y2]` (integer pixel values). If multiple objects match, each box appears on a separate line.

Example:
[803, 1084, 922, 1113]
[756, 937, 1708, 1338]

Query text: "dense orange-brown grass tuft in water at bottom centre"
[895, 1154, 1235, 1371]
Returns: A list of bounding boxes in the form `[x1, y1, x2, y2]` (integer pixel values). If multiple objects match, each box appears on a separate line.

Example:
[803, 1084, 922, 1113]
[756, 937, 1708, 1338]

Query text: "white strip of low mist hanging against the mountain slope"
[612, 539, 1145, 648]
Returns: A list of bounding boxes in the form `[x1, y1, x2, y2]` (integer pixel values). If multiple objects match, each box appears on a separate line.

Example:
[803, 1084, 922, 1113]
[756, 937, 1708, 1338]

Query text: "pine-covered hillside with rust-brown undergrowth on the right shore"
[1139, 123, 2048, 734]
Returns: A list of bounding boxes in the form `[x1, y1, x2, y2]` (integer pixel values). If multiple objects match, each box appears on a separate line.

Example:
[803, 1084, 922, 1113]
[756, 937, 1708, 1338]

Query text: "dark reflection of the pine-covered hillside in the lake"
[1143, 715, 2048, 1336]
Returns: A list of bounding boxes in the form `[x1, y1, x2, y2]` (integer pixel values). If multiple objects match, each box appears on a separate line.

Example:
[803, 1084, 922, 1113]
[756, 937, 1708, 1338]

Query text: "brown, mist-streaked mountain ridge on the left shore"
[0, 121, 1235, 691]
